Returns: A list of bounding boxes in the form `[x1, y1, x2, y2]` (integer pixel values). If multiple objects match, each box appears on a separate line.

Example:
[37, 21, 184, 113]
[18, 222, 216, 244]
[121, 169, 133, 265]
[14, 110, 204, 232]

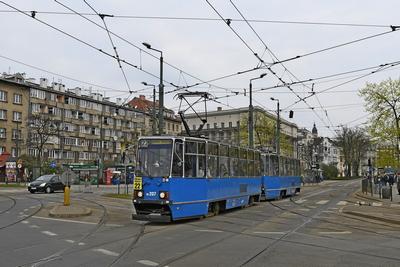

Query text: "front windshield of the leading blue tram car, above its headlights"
[136, 139, 172, 177]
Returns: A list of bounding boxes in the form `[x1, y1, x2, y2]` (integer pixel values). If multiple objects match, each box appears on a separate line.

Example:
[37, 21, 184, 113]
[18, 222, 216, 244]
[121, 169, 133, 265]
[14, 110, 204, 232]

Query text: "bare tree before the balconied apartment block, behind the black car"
[28, 114, 59, 165]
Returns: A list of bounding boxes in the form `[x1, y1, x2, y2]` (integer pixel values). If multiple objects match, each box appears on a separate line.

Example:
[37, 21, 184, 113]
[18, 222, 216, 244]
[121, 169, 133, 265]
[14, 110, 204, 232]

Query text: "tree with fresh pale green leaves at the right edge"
[360, 78, 400, 169]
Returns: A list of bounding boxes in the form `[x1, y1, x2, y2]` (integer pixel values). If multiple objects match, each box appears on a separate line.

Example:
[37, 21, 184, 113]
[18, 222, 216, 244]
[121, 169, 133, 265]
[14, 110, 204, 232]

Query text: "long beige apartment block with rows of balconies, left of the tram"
[0, 74, 151, 168]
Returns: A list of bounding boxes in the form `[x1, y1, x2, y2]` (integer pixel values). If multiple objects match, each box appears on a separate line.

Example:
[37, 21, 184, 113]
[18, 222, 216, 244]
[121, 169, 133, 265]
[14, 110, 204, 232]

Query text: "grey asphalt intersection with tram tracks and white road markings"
[0, 180, 400, 266]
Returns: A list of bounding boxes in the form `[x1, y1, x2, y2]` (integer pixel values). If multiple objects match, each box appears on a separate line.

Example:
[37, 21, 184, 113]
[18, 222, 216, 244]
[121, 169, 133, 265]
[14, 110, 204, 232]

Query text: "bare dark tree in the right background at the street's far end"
[333, 126, 370, 177]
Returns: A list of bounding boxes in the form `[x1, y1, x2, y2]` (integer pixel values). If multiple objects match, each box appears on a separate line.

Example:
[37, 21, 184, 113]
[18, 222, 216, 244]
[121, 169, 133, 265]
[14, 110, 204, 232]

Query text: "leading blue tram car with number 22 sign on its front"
[132, 136, 261, 222]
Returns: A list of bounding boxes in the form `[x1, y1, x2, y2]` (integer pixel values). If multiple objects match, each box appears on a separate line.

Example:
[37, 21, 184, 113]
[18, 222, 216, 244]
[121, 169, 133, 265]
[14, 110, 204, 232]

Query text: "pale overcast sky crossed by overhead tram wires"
[0, 0, 400, 136]
